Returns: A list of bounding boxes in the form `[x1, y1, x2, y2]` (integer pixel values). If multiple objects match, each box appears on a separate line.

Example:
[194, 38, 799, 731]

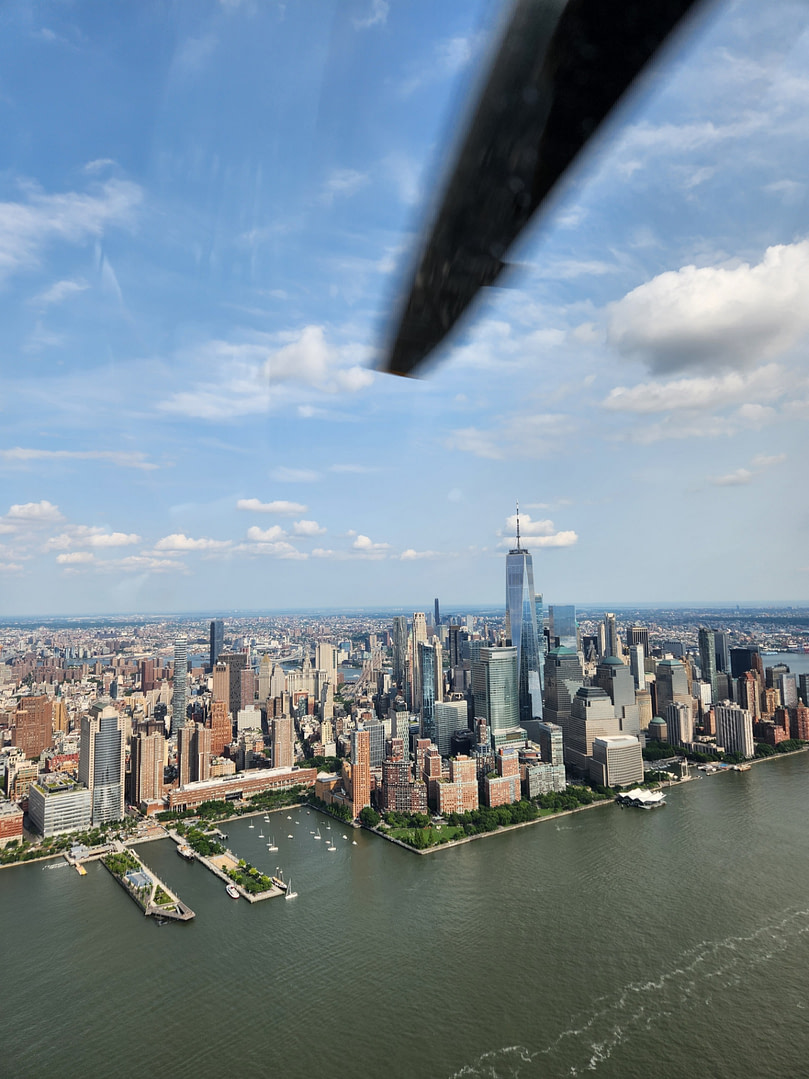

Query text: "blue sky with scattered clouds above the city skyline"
[0, 0, 809, 615]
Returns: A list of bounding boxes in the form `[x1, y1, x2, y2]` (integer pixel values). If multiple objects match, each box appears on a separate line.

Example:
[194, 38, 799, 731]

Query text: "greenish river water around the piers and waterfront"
[0, 754, 809, 1079]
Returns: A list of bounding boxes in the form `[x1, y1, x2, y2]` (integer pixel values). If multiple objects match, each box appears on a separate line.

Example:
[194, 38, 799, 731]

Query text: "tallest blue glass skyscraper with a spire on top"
[506, 507, 543, 723]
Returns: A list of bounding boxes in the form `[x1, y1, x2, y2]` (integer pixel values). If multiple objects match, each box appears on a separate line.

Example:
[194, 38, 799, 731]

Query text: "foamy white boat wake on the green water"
[450, 910, 809, 1079]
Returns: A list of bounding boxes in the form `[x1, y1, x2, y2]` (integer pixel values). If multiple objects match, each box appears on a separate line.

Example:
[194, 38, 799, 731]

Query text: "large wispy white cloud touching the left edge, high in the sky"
[0, 179, 142, 281]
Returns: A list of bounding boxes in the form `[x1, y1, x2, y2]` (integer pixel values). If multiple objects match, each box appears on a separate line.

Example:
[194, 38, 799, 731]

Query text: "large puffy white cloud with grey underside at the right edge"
[607, 241, 809, 373]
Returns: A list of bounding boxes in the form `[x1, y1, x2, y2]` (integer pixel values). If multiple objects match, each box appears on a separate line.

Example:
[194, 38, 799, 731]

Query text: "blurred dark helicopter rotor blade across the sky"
[382, 0, 696, 374]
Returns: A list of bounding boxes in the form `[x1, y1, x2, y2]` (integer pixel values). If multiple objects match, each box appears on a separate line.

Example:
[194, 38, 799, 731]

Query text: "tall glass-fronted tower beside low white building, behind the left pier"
[79, 706, 126, 825]
